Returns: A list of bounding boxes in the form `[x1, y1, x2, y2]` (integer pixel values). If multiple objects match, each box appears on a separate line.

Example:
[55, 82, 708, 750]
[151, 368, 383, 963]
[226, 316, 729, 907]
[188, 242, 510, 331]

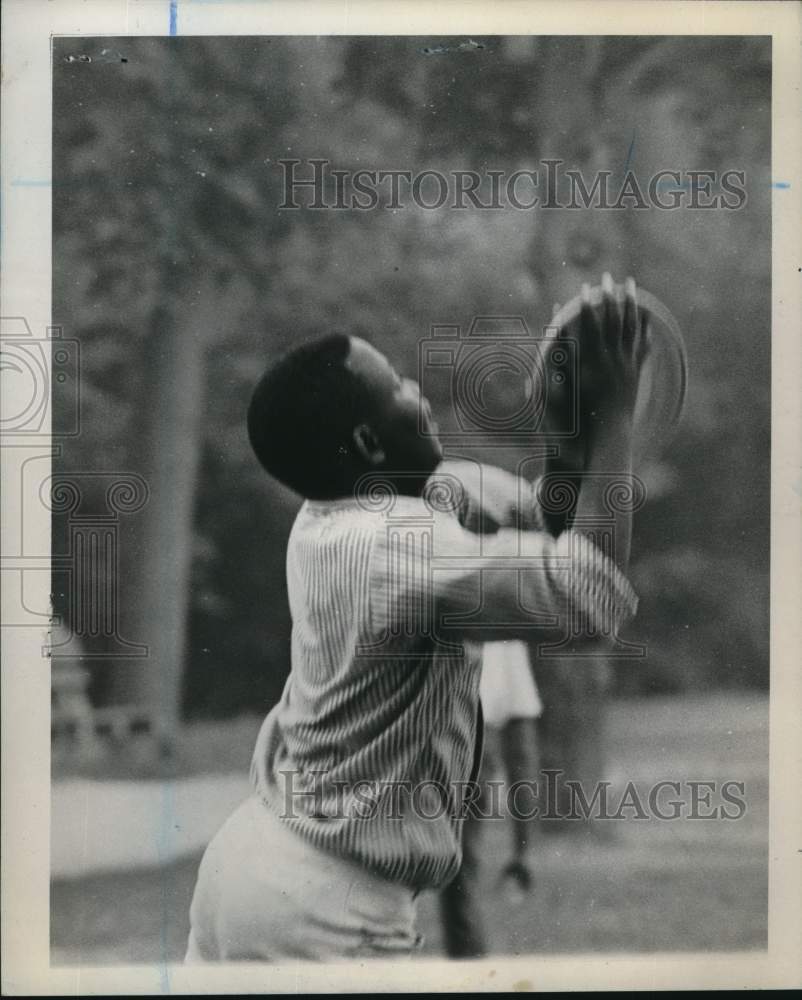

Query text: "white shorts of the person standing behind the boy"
[479, 639, 543, 727]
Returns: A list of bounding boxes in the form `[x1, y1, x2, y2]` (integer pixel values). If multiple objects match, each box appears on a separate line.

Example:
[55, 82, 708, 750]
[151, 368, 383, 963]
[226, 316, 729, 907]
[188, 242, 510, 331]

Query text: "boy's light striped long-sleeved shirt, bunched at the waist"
[251, 463, 636, 888]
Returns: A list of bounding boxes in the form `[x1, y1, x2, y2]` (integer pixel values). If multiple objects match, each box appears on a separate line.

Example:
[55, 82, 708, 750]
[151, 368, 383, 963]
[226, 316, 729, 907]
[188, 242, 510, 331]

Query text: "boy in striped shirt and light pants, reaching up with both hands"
[187, 276, 647, 962]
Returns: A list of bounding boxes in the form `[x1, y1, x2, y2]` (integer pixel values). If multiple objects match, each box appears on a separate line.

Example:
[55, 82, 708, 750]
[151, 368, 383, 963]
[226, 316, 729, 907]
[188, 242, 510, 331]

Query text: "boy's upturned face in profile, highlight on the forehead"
[346, 337, 443, 475]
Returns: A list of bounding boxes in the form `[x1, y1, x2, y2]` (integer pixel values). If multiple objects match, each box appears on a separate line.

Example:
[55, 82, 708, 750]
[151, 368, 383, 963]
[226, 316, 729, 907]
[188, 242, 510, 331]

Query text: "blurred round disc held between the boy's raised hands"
[547, 285, 688, 460]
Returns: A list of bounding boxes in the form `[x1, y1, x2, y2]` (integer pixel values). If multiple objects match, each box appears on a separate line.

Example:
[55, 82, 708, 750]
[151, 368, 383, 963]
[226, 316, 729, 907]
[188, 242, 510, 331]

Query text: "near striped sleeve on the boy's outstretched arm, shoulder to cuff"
[370, 494, 637, 642]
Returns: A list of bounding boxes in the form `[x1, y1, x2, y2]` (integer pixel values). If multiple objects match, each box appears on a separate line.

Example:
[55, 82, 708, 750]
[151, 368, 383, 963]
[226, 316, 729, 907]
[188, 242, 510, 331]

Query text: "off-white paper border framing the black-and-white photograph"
[0, 0, 802, 995]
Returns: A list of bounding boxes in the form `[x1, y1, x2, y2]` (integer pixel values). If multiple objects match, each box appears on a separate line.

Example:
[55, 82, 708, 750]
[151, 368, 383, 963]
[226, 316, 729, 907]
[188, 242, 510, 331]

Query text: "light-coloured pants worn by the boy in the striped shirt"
[185, 796, 421, 963]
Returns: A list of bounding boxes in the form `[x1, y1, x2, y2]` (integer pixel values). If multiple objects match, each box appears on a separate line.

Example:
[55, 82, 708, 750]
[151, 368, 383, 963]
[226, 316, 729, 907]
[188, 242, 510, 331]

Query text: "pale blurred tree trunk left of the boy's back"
[111, 277, 220, 743]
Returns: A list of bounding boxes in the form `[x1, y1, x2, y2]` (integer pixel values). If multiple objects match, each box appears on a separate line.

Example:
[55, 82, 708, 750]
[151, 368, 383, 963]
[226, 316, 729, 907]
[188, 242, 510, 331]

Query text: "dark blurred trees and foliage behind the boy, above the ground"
[53, 37, 771, 717]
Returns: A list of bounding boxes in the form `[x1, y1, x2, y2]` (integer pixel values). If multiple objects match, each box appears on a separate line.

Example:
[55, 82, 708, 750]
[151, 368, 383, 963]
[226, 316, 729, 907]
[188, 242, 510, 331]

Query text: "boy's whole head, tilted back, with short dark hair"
[248, 333, 442, 500]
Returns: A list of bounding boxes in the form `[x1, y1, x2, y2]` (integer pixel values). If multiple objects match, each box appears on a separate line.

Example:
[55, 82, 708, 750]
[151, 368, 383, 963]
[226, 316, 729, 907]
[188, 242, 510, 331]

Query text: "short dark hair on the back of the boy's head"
[248, 333, 365, 500]
